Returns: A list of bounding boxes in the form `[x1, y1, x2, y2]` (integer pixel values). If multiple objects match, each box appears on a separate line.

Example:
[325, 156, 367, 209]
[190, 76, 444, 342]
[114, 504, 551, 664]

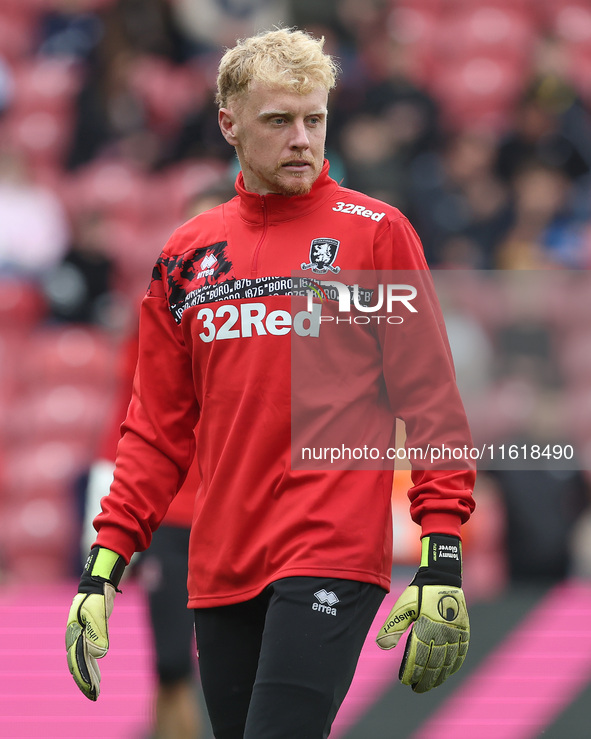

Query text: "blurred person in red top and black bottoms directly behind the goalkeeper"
[80, 182, 236, 739]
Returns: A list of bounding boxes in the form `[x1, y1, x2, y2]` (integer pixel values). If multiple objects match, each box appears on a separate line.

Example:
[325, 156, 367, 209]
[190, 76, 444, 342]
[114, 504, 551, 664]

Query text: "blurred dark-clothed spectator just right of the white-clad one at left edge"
[43, 212, 116, 326]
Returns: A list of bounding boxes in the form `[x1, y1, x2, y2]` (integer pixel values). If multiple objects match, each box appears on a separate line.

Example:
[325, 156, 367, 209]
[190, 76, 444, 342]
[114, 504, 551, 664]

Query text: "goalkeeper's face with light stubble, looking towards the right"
[219, 82, 328, 195]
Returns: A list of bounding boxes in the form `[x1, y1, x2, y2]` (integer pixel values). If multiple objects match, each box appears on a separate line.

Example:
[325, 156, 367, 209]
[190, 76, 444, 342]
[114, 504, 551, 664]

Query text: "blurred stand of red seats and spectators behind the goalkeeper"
[0, 0, 591, 592]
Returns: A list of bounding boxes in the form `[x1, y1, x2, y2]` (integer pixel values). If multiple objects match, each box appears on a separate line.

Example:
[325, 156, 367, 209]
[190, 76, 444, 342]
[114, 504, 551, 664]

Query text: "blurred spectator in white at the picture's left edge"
[0, 149, 69, 278]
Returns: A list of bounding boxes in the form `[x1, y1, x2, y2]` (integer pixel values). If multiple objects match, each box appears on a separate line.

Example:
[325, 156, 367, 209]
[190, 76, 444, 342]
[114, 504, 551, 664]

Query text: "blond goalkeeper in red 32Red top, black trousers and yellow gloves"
[66, 29, 475, 739]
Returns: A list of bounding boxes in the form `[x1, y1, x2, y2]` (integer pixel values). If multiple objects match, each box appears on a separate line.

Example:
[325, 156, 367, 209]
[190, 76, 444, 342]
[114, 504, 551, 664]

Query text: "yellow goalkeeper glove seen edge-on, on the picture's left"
[66, 547, 125, 701]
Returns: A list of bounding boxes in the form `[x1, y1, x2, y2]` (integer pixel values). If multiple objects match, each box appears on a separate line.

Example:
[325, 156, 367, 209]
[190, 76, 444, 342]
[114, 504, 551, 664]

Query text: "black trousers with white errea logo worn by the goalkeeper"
[195, 577, 386, 739]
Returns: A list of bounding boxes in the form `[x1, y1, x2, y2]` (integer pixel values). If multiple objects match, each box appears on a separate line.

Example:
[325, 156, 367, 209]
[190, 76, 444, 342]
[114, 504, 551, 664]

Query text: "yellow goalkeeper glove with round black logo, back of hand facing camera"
[376, 534, 470, 693]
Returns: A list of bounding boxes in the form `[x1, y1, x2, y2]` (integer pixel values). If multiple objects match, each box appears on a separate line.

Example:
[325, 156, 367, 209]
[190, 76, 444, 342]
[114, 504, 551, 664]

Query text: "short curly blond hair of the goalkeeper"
[216, 28, 339, 108]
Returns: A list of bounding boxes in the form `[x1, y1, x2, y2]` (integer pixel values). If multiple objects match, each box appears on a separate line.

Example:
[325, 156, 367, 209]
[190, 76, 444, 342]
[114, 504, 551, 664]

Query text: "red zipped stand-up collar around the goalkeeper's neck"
[236, 159, 338, 224]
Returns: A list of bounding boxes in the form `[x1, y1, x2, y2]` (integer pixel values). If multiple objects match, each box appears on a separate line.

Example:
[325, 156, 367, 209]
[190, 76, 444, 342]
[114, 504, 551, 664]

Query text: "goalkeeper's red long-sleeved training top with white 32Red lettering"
[95, 162, 474, 607]
